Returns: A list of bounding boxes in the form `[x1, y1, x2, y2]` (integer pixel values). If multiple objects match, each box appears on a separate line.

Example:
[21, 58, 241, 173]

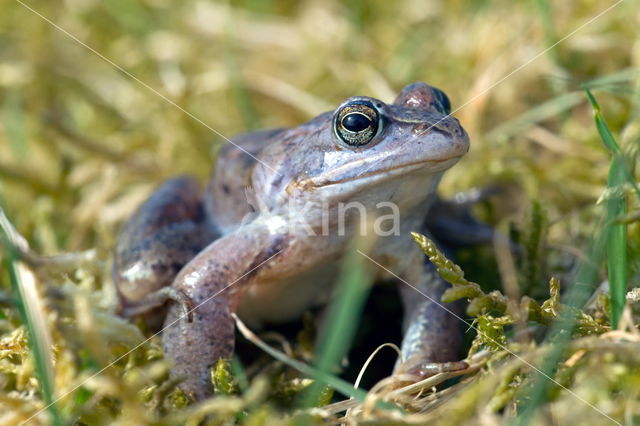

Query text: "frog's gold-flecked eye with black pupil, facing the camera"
[333, 100, 382, 147]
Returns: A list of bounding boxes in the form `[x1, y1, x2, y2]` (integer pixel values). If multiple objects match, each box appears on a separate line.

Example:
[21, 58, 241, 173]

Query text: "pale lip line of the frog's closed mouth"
[297, 154, 464, 189]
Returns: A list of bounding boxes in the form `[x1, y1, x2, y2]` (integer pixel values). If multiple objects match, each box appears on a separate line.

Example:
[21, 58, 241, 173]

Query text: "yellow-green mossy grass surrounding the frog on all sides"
[0, 0, 640, 424]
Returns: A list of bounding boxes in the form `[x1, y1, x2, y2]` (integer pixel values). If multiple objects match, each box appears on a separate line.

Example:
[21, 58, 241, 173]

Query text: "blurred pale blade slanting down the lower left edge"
[0, 207, 66, 425]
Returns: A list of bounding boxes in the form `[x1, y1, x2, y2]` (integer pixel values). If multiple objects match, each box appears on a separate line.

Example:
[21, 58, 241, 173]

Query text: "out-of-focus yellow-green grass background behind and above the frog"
[0, 0, 640, 424]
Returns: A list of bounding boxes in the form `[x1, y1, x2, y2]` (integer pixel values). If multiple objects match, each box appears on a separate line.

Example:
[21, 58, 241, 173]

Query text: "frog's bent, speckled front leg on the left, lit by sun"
[162, 225, 284, 400]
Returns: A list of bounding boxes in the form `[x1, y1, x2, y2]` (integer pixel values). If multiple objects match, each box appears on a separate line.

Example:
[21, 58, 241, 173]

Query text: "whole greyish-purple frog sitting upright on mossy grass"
[113, 82, 469, 400]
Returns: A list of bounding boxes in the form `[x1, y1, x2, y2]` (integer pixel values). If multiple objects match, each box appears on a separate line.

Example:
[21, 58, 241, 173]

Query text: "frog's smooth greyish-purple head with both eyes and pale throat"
[254, 83, 469, 215]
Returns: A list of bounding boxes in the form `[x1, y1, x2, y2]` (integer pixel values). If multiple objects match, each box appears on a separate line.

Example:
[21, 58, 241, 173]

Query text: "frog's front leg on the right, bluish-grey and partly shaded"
[394, 250, 467, 378]
